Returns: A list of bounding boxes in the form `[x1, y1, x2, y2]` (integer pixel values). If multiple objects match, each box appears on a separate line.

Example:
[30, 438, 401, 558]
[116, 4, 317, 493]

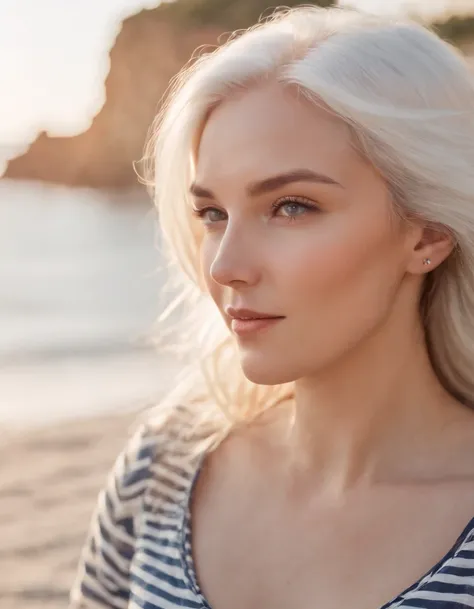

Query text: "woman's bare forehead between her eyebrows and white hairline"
[196, 83, 360, 183]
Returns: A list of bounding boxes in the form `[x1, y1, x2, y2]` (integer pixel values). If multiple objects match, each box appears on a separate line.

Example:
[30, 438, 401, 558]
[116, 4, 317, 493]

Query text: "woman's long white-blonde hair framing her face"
[143, 6, 474, 437]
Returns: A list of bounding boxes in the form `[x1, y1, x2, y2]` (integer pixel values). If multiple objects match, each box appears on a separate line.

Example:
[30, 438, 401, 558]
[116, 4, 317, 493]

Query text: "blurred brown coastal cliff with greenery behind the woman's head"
[6, 0, 474, 189]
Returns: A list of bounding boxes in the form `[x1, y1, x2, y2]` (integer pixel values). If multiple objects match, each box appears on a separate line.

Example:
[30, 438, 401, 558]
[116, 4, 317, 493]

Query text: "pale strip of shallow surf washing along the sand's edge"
[0, 349, 180, 433]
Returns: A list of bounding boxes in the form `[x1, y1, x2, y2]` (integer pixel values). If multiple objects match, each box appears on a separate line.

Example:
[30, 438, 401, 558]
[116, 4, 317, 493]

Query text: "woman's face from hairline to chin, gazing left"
[191, 84, 422, 384]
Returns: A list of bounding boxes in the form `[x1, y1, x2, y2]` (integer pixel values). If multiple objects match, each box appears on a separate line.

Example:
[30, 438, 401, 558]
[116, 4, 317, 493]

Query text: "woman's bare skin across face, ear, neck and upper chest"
[188, 82, 474, 609]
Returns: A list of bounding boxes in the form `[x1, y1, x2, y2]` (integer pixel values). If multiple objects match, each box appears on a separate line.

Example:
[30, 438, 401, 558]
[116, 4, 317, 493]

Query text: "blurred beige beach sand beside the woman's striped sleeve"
[0, 414, 144, 609]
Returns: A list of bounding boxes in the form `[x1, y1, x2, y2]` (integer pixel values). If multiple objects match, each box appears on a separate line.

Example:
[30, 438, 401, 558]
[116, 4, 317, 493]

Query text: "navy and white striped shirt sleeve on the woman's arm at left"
[69, 425, 154, 609]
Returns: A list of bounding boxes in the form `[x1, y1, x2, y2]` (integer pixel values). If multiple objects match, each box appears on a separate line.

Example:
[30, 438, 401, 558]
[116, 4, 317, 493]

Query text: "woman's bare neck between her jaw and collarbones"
[289, 290, 462, 493]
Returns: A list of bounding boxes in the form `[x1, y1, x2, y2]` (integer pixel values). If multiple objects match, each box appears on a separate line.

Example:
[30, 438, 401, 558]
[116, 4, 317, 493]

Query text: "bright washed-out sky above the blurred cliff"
[0, 0, 474, 176]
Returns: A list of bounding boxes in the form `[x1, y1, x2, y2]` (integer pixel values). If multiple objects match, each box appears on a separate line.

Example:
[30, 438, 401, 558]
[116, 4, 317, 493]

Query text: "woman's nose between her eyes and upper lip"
[210, 225, 260, 288]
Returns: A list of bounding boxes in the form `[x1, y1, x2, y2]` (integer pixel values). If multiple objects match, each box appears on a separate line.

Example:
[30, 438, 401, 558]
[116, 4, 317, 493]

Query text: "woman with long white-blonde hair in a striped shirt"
[71, 8, 474, 609]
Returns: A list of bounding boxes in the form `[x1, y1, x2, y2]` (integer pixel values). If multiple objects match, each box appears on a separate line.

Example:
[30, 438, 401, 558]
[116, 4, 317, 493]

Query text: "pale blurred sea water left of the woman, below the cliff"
[0, 179, 176, 427]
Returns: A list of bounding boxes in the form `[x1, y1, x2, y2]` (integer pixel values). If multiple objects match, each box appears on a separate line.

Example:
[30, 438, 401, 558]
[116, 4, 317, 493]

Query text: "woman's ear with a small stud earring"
[407, 225, 454, 275]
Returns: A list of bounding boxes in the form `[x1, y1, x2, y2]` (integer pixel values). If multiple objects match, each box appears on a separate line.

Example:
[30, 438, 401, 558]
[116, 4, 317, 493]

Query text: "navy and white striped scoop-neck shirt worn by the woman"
[69, 408, 474, 609]
